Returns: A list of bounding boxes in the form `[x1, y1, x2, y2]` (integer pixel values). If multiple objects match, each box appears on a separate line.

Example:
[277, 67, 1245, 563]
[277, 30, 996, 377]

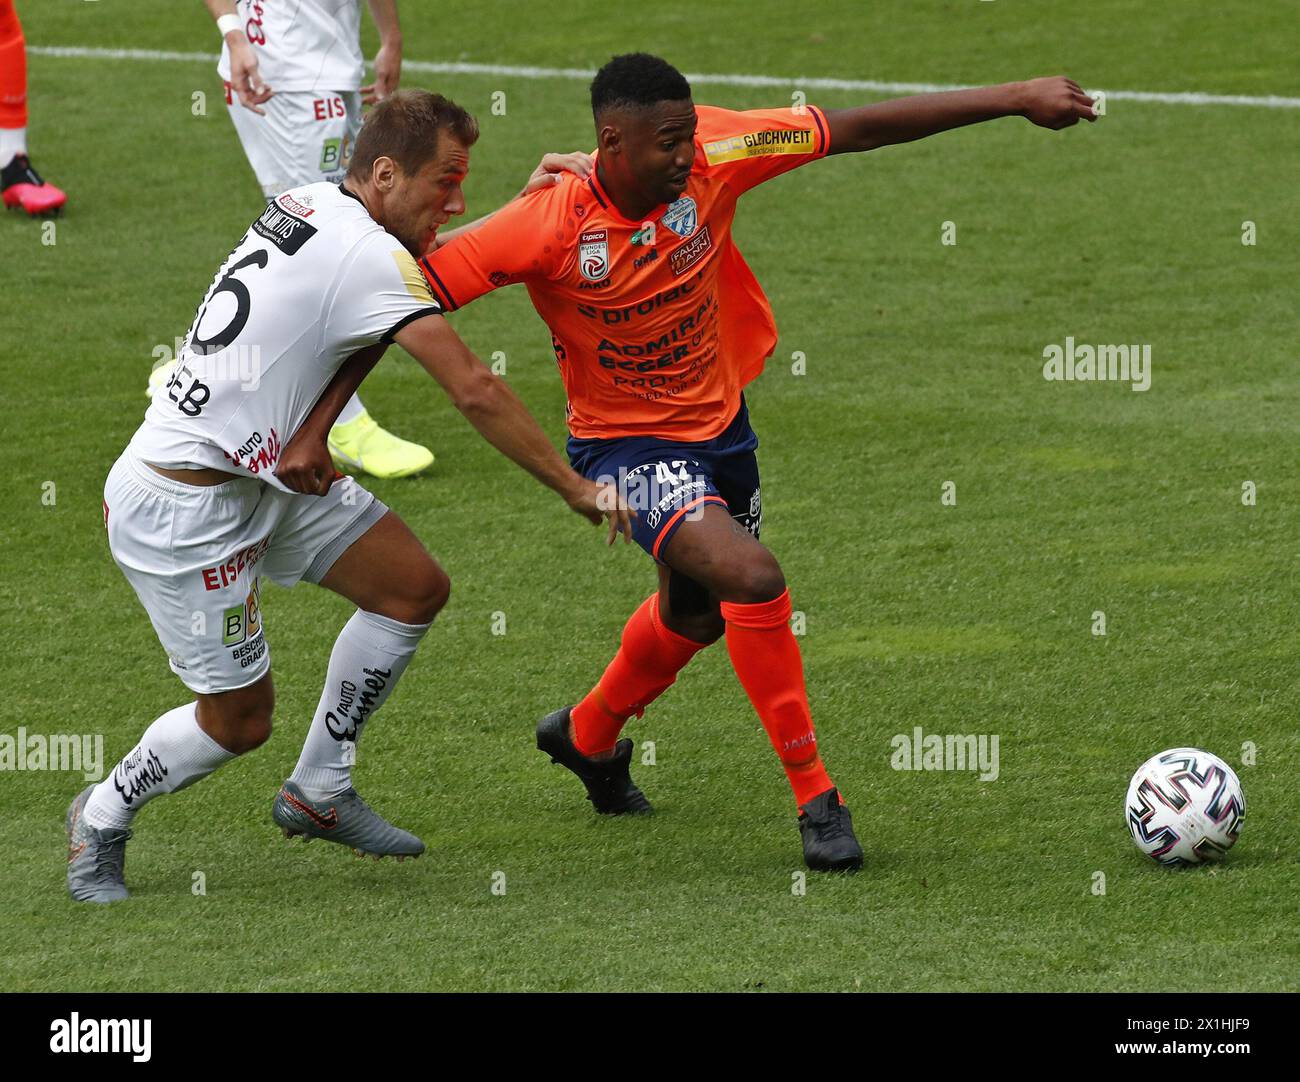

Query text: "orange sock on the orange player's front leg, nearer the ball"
[722, 590, 832, 804]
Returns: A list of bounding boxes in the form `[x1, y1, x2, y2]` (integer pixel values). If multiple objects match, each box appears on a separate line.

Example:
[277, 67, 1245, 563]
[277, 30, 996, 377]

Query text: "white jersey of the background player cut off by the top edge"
[217, 0, 365, 91]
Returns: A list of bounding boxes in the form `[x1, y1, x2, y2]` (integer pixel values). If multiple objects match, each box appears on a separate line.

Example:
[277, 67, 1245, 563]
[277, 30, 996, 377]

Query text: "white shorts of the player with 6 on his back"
[104, 450, 389, 694]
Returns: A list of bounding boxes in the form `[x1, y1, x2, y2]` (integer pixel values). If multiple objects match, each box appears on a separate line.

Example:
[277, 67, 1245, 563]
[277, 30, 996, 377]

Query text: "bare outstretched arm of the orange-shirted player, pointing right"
[826, 75, 1097, 153]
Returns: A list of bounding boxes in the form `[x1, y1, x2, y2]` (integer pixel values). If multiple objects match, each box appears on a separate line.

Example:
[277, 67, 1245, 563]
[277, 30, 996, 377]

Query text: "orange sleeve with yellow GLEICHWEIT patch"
[696, 105, 831, 195]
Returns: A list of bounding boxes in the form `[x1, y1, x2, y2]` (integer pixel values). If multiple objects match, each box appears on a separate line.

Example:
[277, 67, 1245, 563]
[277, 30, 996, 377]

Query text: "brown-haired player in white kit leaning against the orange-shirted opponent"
[66, 91, 631, 901]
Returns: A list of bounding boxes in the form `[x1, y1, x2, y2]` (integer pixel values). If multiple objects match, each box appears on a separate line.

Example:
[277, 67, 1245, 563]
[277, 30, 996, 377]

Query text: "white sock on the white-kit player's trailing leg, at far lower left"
[82, 702, 235, 830]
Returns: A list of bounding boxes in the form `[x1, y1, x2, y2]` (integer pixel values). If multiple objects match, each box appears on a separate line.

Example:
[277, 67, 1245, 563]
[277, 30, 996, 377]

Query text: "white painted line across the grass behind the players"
[27, 46, 1300, 109]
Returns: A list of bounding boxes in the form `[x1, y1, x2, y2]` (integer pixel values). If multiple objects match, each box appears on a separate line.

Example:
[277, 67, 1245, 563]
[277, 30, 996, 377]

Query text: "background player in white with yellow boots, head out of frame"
[205, 0, 433, 477]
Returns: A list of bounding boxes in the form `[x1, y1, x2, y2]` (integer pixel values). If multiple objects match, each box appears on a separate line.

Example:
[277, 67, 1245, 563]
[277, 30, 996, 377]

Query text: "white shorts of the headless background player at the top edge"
[226, 83, 361, 199]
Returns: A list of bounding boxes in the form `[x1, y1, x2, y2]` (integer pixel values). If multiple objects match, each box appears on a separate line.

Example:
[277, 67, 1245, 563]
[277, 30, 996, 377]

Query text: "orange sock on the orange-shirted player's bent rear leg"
[572, 593, 709, 756]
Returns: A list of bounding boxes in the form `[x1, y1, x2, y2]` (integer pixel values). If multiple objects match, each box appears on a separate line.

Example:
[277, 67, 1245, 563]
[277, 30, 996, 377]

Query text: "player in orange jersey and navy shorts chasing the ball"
[287, 53, 1096, 870]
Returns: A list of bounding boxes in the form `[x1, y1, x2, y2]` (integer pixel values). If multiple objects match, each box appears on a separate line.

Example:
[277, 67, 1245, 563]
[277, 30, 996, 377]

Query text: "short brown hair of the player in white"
[347, 90, 478, 178]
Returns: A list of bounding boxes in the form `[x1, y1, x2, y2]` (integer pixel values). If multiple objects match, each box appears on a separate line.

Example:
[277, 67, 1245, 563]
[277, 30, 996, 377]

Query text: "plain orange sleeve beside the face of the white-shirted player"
[420, 190, 559, 311]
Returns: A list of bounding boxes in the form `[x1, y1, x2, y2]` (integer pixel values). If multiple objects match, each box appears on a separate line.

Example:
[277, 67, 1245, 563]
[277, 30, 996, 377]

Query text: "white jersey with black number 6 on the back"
[130, 183, 442, 490]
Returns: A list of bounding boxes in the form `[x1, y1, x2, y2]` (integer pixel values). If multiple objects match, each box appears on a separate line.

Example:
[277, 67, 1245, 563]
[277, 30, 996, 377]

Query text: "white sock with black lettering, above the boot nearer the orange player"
[290, 609, 429, 800]
